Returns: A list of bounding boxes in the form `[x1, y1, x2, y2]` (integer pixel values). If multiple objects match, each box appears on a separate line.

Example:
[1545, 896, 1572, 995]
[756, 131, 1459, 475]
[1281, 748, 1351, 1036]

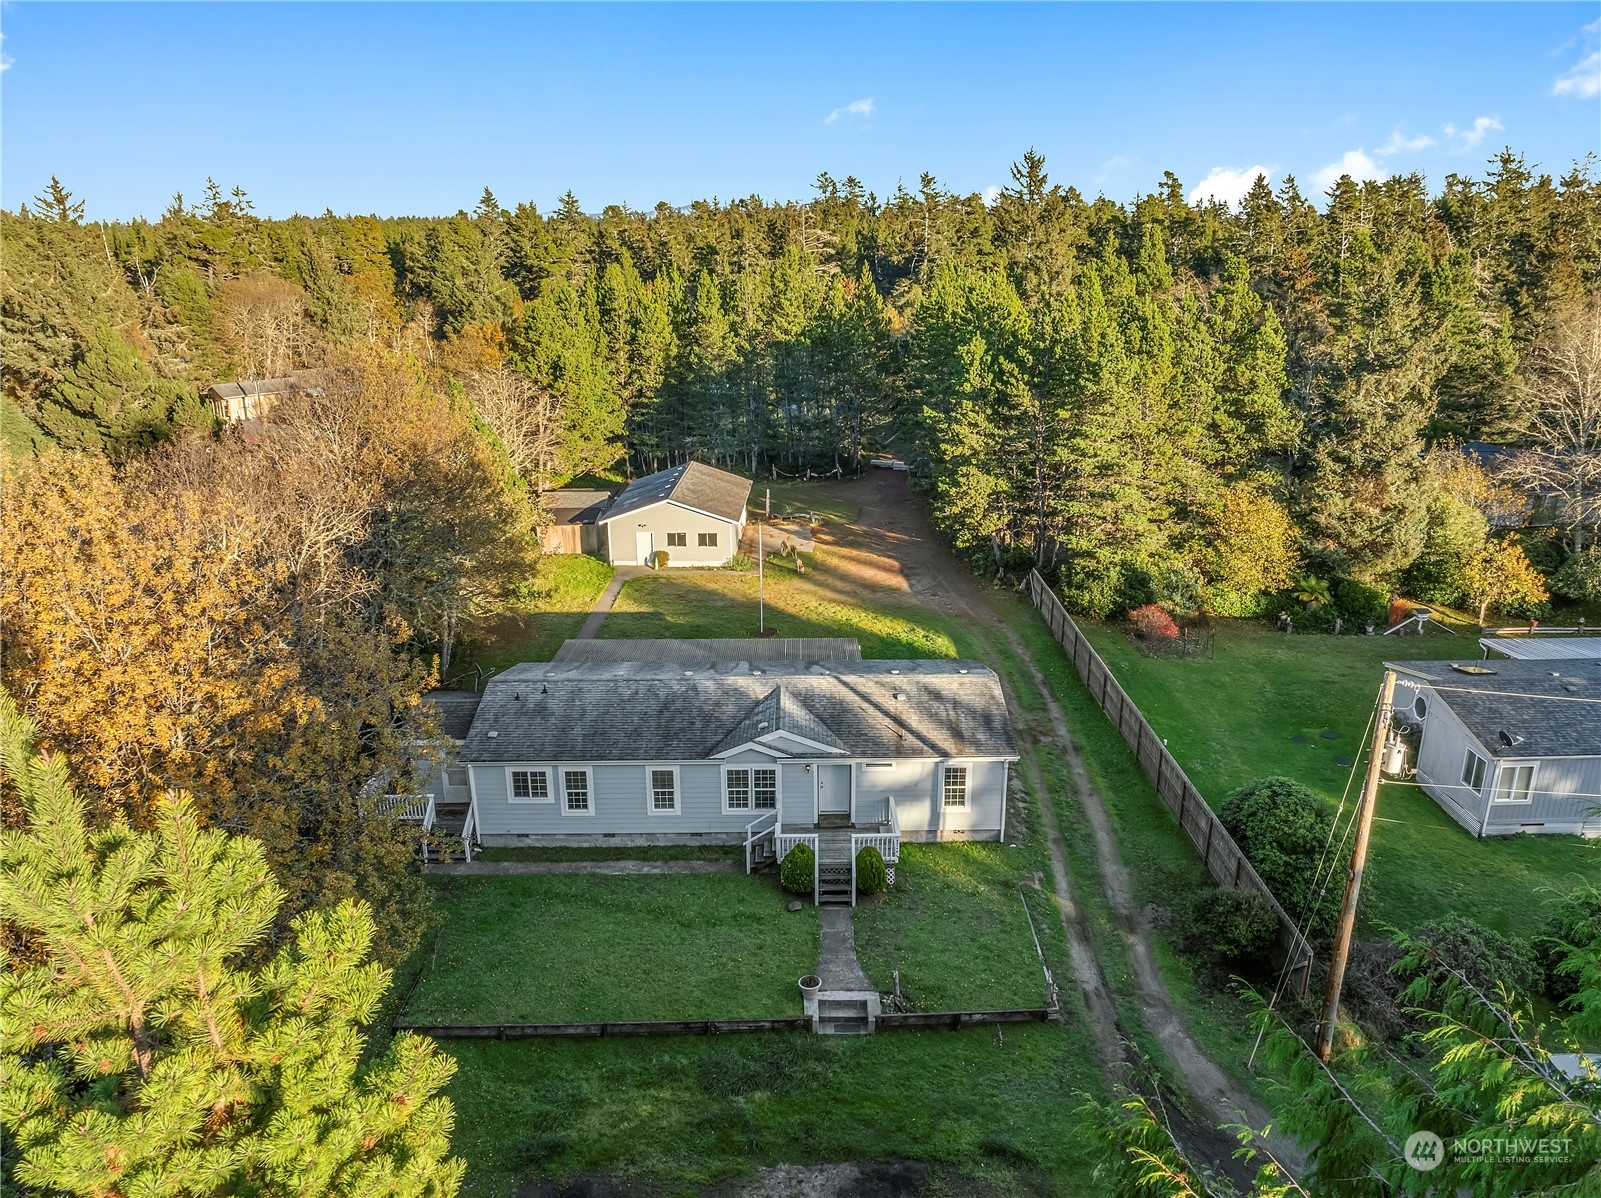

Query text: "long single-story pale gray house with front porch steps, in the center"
[431, 637, 1017, 900]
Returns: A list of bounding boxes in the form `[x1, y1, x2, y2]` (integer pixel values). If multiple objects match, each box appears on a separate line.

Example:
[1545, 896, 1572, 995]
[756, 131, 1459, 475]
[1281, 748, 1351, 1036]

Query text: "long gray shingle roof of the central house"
[461, 661, 1017, 761]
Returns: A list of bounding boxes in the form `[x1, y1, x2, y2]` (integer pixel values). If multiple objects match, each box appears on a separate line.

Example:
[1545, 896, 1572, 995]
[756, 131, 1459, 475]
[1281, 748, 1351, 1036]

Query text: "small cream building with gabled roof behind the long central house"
[599, 461, 751, 565]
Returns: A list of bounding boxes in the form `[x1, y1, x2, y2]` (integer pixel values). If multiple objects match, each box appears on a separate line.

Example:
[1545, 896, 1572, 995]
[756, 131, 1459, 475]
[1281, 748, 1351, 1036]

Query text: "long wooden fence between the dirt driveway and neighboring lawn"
[1028, 570, 1311, 996]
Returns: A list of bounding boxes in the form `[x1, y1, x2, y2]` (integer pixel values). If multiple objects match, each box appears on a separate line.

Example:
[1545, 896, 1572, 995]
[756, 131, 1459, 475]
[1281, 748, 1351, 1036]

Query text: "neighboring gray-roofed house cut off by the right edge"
[1386, 658, 1601, 836]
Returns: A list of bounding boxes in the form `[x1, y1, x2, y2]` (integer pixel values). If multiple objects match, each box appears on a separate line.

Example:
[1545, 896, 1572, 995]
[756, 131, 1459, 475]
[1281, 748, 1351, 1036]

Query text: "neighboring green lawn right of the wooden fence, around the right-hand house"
[1084, 621, 1601, 935]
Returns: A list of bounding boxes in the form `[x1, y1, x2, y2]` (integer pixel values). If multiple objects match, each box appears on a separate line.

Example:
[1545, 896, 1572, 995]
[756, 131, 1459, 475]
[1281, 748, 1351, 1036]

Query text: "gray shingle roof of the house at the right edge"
[1385, 658, 1601, 758]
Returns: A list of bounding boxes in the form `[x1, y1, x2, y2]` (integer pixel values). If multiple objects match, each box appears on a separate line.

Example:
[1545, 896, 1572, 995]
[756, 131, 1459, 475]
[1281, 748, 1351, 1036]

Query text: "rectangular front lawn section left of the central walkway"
[402, 873, 818, 1025]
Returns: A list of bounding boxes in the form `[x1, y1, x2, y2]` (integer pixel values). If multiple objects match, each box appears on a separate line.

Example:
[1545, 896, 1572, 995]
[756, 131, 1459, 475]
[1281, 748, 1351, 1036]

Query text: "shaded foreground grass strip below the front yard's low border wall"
[443, 1025, 1100, 1198]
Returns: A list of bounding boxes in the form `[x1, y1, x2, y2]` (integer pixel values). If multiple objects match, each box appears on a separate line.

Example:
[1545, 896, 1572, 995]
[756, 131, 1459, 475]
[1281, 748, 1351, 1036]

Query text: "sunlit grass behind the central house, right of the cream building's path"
[600, 553, 959, 658]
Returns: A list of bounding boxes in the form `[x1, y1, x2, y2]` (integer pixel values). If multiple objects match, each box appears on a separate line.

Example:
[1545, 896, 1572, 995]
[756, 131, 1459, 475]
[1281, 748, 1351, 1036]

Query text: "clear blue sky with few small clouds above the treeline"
[0, 0, 1601, 218]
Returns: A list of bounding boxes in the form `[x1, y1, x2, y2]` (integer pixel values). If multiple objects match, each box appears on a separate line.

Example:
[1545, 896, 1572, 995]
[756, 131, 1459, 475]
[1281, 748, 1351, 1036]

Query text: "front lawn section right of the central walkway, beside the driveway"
[855, 842, 1050, 1011]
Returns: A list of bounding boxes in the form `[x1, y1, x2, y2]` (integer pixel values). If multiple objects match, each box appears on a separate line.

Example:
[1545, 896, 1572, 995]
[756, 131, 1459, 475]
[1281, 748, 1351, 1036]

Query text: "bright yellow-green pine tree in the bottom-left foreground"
[0, 692, 463, 1198]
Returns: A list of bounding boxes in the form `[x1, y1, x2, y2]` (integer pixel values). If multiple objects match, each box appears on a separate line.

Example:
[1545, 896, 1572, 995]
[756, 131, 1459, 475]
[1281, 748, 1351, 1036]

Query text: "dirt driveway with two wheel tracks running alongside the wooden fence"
[800, 471, 1305, 1182]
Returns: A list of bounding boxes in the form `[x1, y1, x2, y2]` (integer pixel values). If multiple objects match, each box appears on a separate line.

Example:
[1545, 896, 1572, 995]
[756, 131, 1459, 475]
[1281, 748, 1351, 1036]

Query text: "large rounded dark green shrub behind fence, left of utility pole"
[1217, 778, 1340, 932]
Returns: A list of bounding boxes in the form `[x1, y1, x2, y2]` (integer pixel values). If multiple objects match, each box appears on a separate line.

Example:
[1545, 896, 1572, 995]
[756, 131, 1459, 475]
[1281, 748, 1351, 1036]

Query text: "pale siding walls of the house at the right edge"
[1417, 689, 1601, 836]
